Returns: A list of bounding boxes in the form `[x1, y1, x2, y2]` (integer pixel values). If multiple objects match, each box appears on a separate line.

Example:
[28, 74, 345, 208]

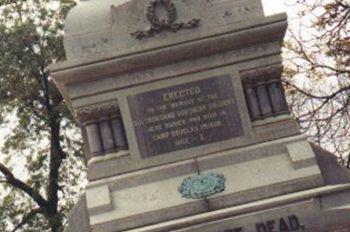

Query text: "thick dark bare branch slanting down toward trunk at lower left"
[0, 163, 47, 208]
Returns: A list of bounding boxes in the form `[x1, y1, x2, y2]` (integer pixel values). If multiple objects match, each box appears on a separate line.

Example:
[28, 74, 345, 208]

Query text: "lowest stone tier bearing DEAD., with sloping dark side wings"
[66, 143, 350, 232]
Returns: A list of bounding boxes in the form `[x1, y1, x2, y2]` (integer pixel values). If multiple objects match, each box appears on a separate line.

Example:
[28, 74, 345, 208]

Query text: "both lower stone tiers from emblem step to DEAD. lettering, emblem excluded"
[87, 136, 350, 232]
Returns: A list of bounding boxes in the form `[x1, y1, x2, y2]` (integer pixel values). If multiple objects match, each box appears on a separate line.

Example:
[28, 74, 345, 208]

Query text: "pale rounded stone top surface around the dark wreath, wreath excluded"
[60, 0, 263, 62]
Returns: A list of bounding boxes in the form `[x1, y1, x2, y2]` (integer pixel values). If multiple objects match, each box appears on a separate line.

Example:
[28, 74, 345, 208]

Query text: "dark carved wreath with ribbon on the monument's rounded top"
[131, 0, 200, 40]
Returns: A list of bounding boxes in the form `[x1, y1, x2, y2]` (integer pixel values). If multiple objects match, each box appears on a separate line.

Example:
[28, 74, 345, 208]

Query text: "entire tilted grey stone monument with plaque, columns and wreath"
[52, 0, 350, 232]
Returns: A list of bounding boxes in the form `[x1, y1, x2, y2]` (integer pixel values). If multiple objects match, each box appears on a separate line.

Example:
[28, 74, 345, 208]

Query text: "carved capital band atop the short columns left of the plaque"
[75, 101, 119, 123]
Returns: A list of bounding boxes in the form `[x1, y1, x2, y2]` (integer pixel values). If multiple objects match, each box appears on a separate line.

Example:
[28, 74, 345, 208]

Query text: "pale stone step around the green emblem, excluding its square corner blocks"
[82, 137, 323, 231]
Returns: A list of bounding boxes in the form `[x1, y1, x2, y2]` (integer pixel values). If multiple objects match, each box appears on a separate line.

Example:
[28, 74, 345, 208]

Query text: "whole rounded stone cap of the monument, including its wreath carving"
[60, 0, 264, 64]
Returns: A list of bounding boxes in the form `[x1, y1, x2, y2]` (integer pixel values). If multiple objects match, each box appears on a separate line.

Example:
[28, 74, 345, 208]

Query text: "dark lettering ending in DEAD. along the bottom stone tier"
[224, 215, 305, 232]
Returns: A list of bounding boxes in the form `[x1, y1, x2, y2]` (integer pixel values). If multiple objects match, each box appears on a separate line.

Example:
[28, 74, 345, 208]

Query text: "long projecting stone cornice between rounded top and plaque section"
[52, 17, 287, 85]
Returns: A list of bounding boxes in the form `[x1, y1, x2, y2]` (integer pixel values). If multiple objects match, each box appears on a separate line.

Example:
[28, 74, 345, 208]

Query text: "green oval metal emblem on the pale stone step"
[179, 173, 225, 199]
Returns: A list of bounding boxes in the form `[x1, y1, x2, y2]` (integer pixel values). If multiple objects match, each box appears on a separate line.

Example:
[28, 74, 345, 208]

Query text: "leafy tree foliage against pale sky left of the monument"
[0, 0, 85, 231]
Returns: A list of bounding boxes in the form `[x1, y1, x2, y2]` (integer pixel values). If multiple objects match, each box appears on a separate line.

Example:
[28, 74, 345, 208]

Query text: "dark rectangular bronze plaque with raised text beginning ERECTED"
[128, 75, 244, 158]
